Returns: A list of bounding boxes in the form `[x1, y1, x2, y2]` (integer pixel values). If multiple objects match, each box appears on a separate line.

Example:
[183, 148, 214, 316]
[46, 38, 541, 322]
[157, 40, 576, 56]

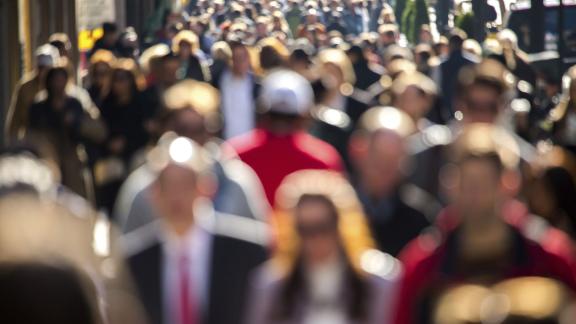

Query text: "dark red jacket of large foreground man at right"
[393, 202, 576, 324]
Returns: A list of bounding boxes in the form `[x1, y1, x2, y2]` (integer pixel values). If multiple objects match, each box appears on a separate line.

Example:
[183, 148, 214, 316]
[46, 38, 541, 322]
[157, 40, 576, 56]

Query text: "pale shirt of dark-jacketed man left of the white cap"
[220, 71, 255, 139]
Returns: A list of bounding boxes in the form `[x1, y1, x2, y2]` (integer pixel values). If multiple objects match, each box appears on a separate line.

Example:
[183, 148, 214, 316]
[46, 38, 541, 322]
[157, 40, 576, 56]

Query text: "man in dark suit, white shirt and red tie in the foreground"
[124, 134, 268, 324]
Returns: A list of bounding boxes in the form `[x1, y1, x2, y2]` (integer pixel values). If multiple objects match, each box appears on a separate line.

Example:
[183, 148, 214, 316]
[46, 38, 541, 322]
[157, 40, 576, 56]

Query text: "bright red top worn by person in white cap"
[230, 129, 343, 206]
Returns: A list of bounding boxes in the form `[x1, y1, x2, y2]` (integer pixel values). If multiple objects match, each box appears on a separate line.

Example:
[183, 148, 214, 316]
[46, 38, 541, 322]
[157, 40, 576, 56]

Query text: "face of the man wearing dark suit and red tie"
[155, 165, 198, 222]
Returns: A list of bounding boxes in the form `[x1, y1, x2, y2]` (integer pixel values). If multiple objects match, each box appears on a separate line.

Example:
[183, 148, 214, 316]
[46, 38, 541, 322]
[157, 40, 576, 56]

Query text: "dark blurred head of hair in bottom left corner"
[0, 263, 97, 324]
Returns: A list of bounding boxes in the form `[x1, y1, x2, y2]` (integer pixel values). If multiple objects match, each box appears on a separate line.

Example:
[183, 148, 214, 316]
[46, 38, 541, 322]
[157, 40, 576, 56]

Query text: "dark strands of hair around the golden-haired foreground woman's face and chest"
[271, 195, 369, 322]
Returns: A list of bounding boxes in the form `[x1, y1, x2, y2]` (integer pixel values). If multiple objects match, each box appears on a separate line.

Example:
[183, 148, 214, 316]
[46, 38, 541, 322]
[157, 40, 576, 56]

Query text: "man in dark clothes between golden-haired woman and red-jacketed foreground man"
[349, 107, 440, 256]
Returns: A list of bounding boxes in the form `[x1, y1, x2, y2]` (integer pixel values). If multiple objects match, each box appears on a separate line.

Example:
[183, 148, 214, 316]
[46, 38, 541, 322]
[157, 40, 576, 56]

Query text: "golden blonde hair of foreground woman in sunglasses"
[273, 170, 375, 271]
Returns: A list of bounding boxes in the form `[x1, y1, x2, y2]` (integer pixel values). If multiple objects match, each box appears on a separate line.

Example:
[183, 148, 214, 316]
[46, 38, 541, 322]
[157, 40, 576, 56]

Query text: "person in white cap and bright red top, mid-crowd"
[230, 70, 342, 204]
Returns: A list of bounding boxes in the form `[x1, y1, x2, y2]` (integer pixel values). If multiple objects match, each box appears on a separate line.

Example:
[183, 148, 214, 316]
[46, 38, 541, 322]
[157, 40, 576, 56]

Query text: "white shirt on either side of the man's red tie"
[162, 220, 212, 324]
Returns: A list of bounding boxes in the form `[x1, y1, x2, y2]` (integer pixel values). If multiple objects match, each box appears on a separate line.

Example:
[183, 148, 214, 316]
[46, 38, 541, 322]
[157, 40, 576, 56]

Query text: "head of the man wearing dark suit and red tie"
[148, 133, 215, 235]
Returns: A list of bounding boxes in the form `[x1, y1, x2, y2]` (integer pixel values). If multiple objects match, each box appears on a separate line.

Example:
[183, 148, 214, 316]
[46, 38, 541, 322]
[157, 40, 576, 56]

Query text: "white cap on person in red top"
[259, 69, 314, 115]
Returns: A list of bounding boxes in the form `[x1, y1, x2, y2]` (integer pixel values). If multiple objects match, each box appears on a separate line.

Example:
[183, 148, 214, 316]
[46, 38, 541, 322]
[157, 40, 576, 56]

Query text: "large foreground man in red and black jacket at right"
[394, 124, 576, 324]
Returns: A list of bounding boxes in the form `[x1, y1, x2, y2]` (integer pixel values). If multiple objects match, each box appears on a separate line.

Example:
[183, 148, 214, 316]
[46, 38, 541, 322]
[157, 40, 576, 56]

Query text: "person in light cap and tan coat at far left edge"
[4, 44, 60, 142]
